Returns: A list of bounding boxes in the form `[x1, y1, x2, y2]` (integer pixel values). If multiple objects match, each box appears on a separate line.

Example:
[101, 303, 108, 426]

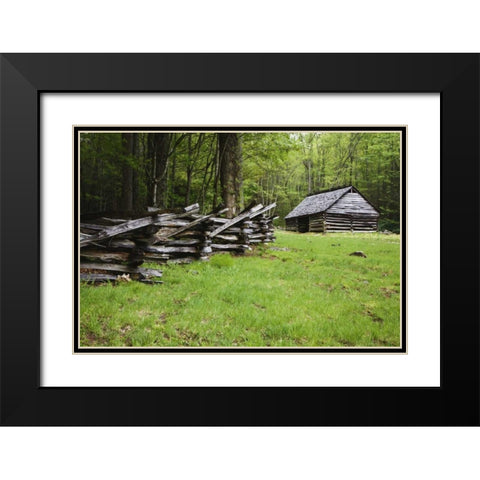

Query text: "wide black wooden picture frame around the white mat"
[0, 54, 480, 426]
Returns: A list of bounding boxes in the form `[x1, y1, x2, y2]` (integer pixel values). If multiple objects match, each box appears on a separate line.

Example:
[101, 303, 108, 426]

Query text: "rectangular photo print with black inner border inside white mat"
[74, 126, 407, 353]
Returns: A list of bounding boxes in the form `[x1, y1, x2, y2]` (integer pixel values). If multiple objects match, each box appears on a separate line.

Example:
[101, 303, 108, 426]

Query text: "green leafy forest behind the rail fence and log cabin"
[79, 131, 401, 233]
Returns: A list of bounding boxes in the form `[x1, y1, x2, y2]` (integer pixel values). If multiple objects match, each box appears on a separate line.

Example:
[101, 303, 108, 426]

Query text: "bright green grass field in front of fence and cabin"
[80, 231, 400, 347]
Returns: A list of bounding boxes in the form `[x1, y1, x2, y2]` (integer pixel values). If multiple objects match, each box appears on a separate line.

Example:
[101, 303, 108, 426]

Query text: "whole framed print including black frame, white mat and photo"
[0, 54, 480, 425]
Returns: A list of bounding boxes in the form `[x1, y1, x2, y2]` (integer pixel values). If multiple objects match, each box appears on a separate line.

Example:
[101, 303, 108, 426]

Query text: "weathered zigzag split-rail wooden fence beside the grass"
[80, 203, 276, 283]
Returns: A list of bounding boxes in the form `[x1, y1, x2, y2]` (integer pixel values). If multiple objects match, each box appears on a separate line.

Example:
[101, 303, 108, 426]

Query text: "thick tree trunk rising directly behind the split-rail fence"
[218, 133, 242, 218]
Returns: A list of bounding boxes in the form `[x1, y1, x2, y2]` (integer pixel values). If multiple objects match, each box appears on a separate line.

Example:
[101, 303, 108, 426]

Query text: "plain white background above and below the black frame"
[0, 0, 480, 480]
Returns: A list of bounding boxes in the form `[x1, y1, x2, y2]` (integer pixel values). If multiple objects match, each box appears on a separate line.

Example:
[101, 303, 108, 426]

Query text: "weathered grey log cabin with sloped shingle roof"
[285, 186, 380, 233]
